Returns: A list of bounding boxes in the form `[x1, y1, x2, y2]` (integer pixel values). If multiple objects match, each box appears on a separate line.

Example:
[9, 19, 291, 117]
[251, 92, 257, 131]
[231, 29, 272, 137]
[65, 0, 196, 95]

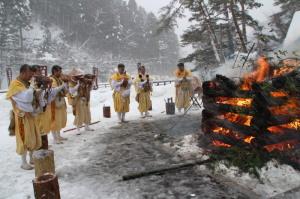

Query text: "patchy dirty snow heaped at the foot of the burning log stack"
[165, 135, 300, 198]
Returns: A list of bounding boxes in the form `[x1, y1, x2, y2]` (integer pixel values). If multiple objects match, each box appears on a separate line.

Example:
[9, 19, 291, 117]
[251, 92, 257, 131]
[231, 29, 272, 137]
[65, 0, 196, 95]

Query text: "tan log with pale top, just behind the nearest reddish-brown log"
[33, 150, 55, 177]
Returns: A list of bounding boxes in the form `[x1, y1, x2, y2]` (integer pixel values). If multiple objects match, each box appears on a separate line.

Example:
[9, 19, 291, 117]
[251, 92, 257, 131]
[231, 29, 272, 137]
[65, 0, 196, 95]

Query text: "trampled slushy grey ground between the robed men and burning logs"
[58, 118, 246, 199]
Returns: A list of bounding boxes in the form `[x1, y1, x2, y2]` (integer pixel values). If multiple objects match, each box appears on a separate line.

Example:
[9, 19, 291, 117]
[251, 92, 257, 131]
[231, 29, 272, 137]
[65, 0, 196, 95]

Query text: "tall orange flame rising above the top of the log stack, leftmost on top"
[240, 56, 270, 91]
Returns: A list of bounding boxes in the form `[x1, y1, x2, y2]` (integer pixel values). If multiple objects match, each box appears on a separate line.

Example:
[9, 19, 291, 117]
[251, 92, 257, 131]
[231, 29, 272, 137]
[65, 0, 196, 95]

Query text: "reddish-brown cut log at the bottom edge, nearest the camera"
[32, 173, 60, 199]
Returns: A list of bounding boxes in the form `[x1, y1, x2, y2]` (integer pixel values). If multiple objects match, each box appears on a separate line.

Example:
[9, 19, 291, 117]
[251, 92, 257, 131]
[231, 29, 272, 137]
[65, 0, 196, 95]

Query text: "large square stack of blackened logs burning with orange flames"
[202, 57, 300, 152]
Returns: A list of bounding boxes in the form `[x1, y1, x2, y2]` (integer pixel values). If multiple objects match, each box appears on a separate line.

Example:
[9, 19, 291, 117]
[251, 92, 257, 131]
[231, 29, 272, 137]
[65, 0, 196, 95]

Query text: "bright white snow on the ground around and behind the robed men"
[0, 84, 175, 199]
